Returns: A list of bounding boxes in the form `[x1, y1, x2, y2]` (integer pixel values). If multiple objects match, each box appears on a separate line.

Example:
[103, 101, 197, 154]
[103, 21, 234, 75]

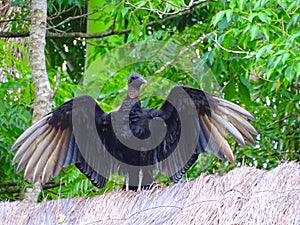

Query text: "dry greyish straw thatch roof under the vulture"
[0, 162, 300, 225]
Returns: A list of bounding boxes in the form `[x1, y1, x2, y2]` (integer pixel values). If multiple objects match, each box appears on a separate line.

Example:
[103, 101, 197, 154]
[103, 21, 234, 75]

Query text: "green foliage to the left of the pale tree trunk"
[0, 41, 33, 200]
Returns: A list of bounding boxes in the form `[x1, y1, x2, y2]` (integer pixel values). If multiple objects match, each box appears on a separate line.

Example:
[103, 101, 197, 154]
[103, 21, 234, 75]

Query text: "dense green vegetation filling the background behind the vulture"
[0, 0, 300, 200]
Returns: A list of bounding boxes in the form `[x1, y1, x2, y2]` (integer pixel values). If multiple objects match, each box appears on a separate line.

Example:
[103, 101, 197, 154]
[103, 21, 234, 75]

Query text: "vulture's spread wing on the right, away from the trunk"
[153, 86, 257, 182]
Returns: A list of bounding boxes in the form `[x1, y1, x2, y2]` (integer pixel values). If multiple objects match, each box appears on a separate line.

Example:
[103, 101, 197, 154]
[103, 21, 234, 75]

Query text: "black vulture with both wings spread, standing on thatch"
[11, 73, 257, 190]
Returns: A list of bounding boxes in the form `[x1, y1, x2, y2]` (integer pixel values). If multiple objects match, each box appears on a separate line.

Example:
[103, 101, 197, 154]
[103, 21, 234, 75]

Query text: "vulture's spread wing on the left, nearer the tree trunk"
[12, 95, 111, 187]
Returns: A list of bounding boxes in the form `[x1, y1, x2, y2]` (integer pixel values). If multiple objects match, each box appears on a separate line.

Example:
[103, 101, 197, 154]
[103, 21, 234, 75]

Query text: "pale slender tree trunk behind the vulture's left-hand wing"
[24, 0, 53, 202]
